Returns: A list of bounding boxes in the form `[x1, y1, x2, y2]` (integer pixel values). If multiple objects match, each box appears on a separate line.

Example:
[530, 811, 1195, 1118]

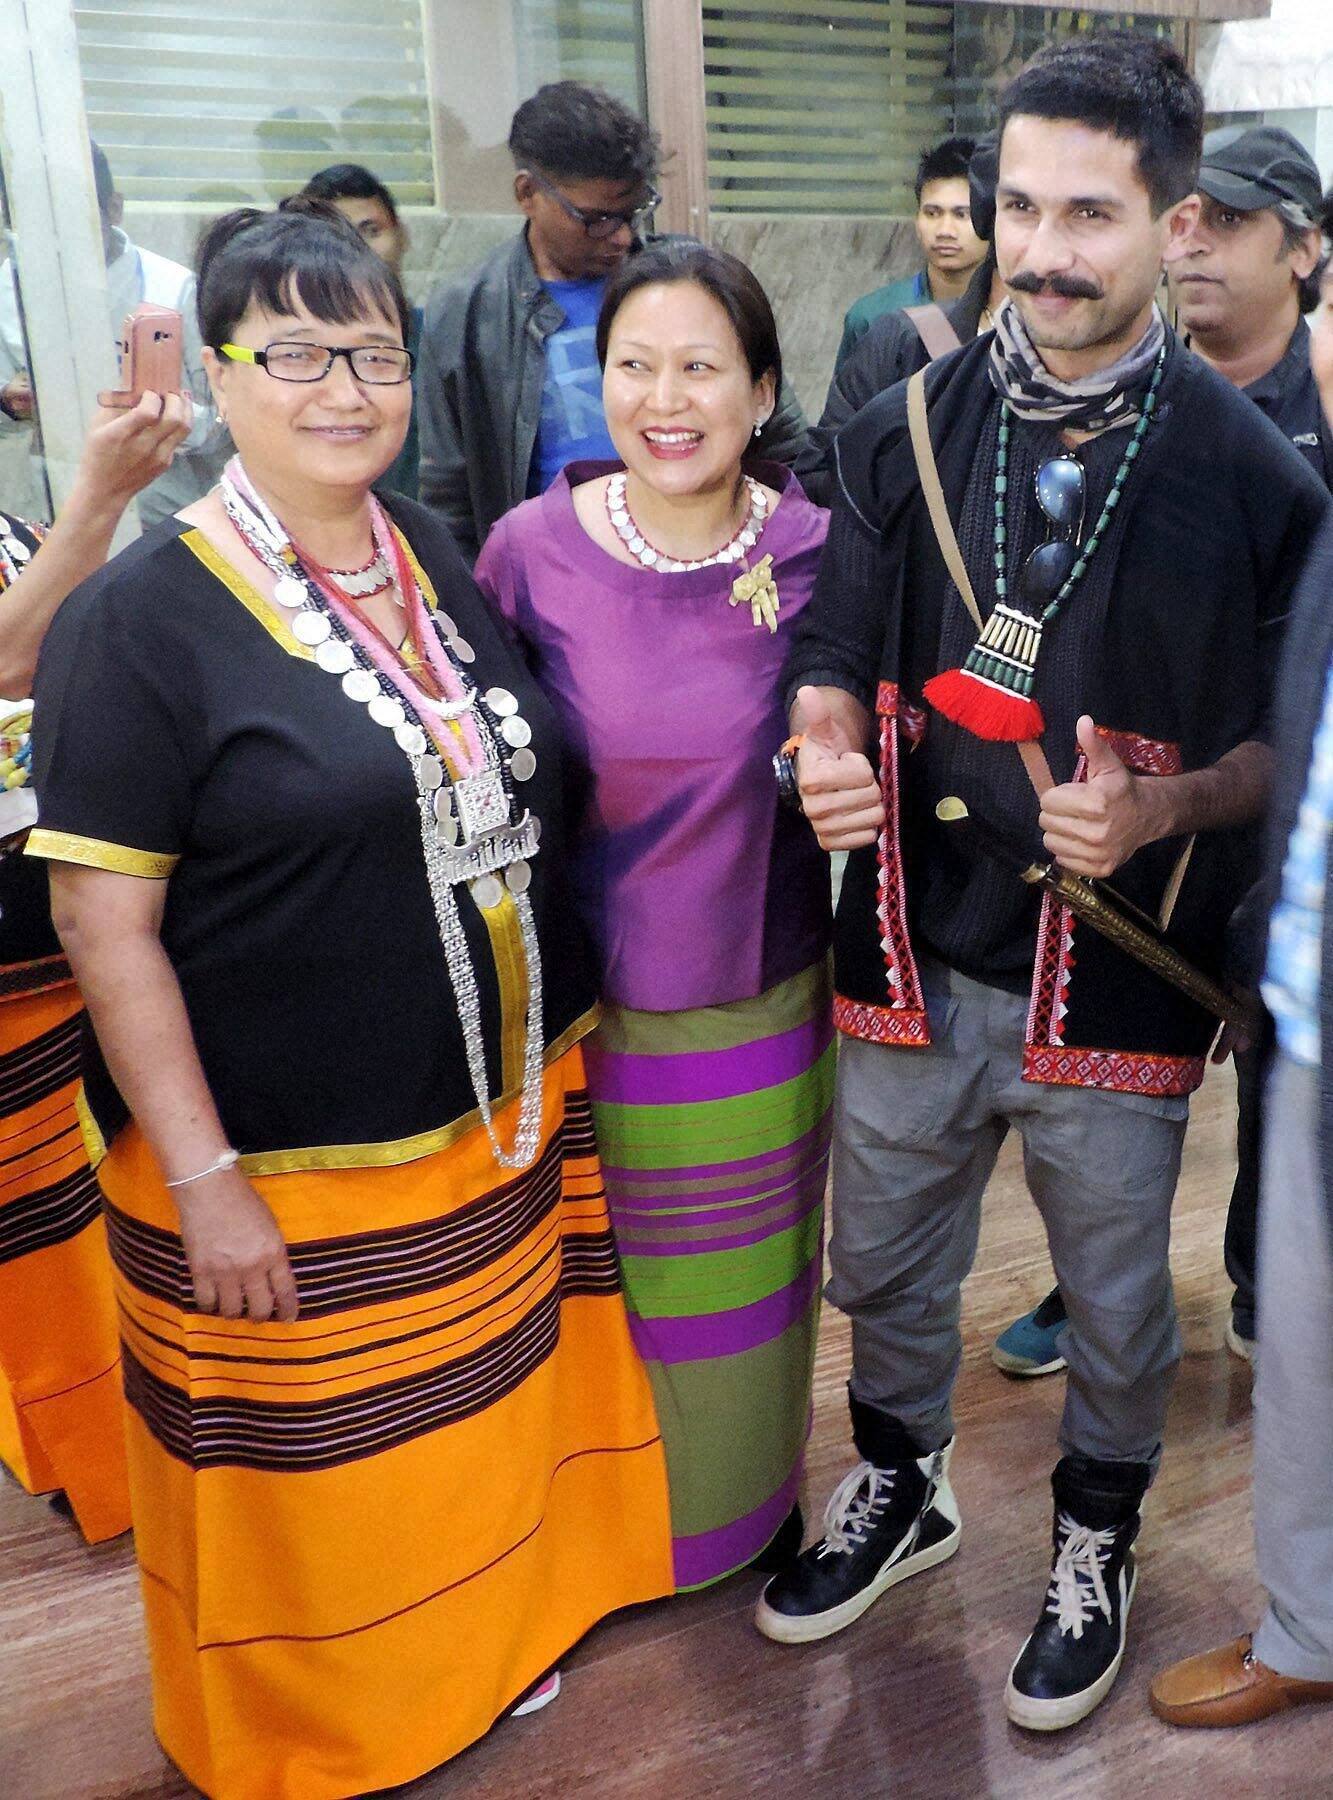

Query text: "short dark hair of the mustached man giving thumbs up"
[1000, 31, 1203, 218]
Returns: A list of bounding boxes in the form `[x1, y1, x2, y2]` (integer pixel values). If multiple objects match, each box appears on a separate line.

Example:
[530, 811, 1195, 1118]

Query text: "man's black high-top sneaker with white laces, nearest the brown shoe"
[1004, 1458, 1148, 1732]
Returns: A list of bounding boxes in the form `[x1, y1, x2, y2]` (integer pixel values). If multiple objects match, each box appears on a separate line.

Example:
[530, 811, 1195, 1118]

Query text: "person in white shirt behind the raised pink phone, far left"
[0, 144, 230, 527]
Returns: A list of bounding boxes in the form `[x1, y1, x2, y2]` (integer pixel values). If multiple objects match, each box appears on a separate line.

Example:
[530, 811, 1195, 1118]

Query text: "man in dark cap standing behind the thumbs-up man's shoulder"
[991, 124, 1333, 1375]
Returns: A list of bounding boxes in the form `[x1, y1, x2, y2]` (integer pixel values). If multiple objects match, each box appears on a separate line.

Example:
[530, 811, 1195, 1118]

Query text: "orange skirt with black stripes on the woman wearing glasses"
[101, 1049, 671, 1800]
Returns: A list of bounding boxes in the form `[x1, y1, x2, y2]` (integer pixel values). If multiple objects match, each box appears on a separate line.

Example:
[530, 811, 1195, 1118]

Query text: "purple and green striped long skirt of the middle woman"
[585, 963, 835, 1588]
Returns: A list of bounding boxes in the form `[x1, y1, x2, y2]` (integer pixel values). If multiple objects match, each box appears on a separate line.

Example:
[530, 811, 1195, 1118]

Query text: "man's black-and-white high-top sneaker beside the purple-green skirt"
[754, 1440, 961, 1643]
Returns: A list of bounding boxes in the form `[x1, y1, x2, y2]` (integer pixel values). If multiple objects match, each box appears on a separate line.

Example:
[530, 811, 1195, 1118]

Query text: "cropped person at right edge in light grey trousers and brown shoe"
[1151, 235, 1333, 1728]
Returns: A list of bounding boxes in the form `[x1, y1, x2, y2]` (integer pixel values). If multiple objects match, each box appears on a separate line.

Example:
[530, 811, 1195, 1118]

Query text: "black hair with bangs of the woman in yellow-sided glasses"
[196, 194, 408, 349]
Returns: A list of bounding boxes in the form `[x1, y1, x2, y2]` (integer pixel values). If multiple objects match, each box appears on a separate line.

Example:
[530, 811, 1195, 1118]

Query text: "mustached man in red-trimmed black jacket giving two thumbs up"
[756, 32, 1328, 1732]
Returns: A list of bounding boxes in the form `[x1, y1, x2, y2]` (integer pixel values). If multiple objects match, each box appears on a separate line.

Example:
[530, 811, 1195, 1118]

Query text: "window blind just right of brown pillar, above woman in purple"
[703, 0, 953, 214]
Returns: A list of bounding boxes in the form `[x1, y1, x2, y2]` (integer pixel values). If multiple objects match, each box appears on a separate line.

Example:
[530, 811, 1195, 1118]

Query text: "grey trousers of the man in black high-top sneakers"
[828, 963, 1189, 1465]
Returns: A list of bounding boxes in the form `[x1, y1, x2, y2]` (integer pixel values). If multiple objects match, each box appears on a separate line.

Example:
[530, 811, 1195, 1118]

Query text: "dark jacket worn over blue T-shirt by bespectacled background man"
[417, 229, 806, 562]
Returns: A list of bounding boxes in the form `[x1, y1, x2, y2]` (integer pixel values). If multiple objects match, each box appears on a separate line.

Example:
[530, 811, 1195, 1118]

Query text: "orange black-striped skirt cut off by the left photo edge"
[0, 963, 130, 1543]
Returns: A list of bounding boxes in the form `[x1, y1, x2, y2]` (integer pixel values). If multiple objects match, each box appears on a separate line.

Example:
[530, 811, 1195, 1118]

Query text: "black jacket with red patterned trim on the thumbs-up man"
[786, 337, 1328, 1093]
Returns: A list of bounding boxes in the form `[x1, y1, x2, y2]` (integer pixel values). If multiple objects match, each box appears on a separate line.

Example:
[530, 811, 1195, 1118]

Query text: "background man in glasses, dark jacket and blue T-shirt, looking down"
[417, 81, 806, 560]
